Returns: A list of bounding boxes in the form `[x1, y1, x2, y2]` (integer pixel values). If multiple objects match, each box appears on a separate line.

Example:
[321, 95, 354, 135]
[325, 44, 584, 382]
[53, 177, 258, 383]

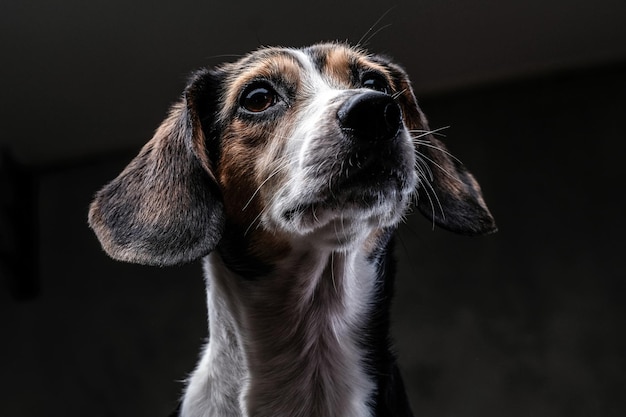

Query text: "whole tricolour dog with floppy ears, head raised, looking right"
[89, 43, 496, 417]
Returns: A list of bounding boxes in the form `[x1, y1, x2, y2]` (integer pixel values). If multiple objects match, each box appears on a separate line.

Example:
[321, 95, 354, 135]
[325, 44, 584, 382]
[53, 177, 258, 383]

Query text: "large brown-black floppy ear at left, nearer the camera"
[89, 71, 223, 265]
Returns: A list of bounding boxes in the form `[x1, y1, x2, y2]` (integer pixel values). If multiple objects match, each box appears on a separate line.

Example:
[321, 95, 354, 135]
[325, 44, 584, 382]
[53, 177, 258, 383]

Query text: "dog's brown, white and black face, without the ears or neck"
[215, 45, 417, 250]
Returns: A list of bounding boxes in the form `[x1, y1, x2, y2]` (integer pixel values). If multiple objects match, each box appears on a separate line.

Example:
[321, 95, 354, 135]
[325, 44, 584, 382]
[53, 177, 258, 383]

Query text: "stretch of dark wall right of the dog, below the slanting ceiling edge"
[398, 62, 626, 416]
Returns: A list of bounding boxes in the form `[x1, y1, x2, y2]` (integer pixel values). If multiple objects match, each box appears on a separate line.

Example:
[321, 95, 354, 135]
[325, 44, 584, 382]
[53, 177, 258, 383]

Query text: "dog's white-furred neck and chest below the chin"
[183, 237, 377, 417]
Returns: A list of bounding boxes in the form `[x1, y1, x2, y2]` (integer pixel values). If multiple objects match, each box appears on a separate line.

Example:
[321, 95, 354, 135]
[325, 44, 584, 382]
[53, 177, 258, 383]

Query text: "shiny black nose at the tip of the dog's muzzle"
[337, 91, 402, 140]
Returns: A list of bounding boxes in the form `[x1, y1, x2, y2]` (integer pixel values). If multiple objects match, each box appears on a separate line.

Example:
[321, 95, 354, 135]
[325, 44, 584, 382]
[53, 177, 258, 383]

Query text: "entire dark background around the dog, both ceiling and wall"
[0, 0, 626, 417]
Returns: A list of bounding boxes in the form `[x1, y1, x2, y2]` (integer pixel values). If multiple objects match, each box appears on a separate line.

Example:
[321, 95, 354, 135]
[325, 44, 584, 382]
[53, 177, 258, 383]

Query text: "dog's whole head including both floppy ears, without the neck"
[89, 44, 495, 265]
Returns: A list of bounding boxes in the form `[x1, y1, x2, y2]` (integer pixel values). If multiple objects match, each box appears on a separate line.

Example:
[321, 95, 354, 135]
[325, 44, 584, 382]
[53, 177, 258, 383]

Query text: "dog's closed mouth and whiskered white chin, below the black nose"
[275, 132, 416, 239]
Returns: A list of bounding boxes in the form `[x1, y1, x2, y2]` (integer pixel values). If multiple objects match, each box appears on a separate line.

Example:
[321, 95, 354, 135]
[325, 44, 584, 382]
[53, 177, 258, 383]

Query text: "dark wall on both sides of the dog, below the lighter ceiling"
[0, 62, 626, 417]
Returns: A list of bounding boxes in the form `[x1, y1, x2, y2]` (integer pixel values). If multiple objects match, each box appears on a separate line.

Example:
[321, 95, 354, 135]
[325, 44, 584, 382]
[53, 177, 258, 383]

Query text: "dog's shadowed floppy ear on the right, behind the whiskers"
[388, 64, 497, 236]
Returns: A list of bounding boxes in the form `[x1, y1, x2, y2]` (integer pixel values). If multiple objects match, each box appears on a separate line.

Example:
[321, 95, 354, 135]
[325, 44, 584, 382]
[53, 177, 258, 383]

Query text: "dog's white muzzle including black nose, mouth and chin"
[270, 90, 416, 236]
